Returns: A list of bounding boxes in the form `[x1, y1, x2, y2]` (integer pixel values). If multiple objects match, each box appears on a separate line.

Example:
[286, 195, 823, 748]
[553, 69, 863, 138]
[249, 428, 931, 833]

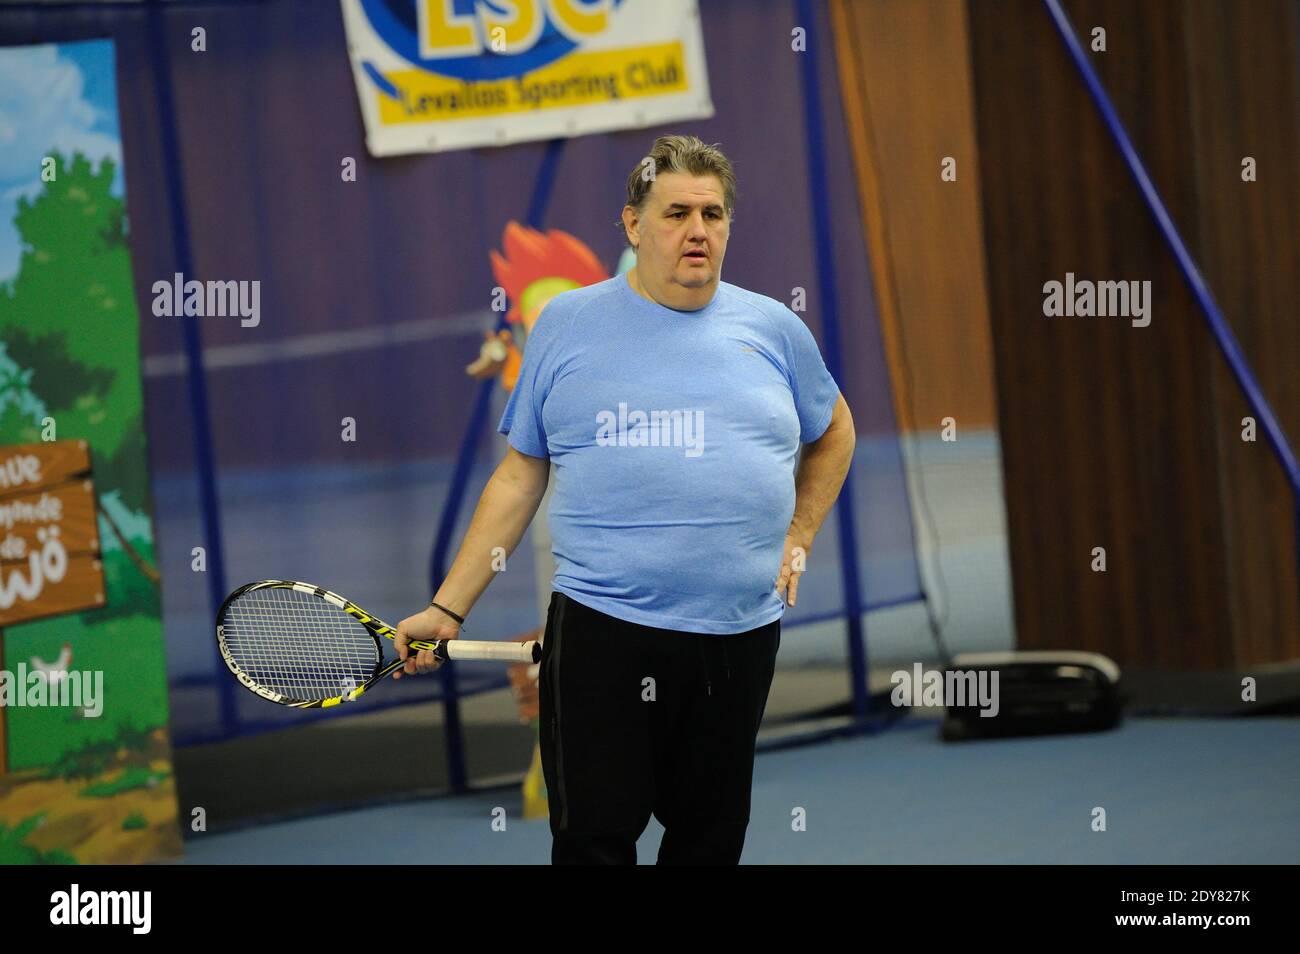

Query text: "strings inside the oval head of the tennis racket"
[224, 587, 380, 699]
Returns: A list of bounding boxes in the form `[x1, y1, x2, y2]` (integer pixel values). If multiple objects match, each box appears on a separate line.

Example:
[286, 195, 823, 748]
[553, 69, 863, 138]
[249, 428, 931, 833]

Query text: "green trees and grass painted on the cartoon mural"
[0, 153, 166, 768]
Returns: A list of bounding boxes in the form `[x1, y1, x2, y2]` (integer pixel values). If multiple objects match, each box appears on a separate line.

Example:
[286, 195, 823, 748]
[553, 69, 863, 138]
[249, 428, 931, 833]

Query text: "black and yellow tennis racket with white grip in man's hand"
[217, 580, 542, 708]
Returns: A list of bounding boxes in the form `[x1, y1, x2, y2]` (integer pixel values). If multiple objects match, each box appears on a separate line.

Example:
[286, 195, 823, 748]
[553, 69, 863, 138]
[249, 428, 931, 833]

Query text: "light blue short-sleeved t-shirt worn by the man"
[498, 276, 840, 633]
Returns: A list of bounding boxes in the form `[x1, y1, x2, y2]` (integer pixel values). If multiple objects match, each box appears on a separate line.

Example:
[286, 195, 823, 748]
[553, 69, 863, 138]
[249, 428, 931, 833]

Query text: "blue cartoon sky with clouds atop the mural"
[0, 40, 124, 282]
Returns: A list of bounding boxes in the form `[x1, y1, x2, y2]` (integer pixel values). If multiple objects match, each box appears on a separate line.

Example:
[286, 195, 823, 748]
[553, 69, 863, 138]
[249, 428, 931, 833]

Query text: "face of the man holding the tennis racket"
[624, 173, 731, 289]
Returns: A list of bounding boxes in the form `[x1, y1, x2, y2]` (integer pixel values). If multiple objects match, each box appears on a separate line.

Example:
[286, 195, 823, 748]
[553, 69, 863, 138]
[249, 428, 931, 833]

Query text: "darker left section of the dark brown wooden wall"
[967, 0, 1231, 668]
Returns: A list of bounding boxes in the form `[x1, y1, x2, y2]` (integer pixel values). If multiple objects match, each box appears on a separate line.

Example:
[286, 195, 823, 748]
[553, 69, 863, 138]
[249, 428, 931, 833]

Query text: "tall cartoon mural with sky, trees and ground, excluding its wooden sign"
[0, 40, 181, 864]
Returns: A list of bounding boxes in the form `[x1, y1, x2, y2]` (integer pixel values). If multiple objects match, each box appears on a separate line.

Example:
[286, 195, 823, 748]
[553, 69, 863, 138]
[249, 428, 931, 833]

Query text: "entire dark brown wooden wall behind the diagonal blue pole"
[967, 0, 1300, 669]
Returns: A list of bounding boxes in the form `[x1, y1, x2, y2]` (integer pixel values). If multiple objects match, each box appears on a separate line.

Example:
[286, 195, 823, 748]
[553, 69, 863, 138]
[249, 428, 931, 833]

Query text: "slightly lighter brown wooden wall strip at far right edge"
[1184, 0, 1300, 664]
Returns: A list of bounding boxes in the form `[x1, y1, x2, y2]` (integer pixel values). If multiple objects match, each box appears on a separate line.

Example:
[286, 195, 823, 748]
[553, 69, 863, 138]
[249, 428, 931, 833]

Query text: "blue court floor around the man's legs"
[185, 719, 1300, 864]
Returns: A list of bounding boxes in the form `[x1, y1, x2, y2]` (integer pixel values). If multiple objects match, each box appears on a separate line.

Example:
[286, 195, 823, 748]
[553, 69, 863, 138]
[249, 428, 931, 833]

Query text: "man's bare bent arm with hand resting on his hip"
[776, 394, 858, 606]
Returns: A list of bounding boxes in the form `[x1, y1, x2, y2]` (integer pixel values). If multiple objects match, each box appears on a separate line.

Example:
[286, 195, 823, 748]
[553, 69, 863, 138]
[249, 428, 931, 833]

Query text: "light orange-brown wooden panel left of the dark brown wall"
[831, 0, 995, 433]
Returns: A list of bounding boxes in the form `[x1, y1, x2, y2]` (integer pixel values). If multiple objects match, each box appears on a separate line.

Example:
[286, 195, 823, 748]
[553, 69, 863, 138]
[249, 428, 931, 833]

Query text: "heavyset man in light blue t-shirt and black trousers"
[394, 135, 855, 864]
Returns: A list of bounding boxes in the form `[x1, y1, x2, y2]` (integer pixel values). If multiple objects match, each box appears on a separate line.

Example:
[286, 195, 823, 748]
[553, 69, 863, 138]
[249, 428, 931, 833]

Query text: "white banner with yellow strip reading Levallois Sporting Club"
[341, 0, 714, 156]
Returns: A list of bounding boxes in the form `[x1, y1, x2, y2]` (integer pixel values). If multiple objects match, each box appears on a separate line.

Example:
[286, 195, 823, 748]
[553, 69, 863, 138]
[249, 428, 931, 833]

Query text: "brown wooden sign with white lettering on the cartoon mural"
[0, 441, 104, 626]
